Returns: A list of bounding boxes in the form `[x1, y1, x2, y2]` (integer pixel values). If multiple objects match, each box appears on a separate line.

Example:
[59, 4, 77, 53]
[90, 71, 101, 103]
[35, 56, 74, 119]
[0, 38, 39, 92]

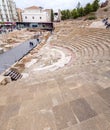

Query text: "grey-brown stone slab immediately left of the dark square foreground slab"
[53, 104, 77, 130]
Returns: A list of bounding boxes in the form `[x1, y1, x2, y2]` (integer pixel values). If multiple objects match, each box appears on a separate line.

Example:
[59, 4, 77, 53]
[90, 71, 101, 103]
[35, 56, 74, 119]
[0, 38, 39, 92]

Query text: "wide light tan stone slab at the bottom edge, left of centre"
[7, 110, 56, 130]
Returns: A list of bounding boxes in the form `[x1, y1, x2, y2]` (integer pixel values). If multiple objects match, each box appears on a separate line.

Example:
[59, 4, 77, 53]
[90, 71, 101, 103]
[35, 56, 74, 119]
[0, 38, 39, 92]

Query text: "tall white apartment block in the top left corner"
[0, 0, 18, 22]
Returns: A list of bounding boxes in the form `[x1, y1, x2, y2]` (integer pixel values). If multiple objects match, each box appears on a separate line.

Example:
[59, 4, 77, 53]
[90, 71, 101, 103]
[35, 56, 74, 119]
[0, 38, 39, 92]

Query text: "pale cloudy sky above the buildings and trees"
[14, 0, 105, 10]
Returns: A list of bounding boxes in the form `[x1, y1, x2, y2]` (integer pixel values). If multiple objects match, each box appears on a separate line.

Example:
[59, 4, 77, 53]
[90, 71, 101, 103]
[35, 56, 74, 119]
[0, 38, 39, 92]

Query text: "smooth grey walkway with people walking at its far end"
[0, 39, 38, 73]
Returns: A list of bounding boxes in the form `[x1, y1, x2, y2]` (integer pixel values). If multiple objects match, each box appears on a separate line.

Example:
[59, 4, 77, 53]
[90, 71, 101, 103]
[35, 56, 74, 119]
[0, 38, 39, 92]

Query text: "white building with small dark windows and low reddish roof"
[22, 6, 51, 22]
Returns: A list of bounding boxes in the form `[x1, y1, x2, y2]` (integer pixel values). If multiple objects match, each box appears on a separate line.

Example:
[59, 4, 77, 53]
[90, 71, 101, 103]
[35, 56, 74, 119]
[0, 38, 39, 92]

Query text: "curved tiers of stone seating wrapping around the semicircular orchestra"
[9, 26, 110, 91]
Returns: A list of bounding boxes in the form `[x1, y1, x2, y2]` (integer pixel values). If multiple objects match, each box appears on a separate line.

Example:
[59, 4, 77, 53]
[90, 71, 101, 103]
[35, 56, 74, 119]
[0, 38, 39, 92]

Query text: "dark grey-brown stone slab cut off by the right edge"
[99, 87, 110, 104]
